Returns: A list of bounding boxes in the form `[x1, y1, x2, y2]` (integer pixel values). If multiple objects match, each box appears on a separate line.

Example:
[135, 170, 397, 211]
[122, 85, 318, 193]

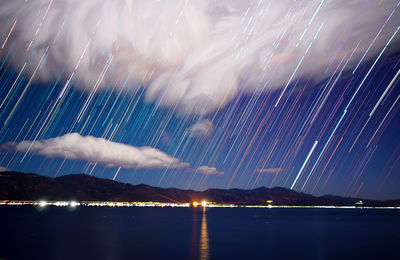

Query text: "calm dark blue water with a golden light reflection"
[0, 206, 400, 259]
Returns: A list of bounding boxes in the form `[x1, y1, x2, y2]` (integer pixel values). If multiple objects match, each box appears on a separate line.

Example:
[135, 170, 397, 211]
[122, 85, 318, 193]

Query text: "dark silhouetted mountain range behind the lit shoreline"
[0, 171, 400, 206]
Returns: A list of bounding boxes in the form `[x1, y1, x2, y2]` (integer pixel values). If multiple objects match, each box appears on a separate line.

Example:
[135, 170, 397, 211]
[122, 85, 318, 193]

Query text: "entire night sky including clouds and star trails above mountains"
[0, 0, 400, 199]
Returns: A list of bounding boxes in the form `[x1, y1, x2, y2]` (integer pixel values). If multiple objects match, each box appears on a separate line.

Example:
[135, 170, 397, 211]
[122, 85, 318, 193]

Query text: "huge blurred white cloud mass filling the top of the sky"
[0, 0, 400, 114]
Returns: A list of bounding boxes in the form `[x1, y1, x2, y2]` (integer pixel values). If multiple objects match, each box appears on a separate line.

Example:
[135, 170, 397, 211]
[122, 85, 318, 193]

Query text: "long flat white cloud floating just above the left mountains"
[0, 133, 189, 169]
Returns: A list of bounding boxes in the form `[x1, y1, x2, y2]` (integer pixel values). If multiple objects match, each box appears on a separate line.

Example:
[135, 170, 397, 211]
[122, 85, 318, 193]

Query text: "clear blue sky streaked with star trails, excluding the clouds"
[0, 0, 400, 199]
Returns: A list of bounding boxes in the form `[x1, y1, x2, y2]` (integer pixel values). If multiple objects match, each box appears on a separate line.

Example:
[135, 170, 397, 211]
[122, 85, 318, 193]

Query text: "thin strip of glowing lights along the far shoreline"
[0, 200, 400, 209]
